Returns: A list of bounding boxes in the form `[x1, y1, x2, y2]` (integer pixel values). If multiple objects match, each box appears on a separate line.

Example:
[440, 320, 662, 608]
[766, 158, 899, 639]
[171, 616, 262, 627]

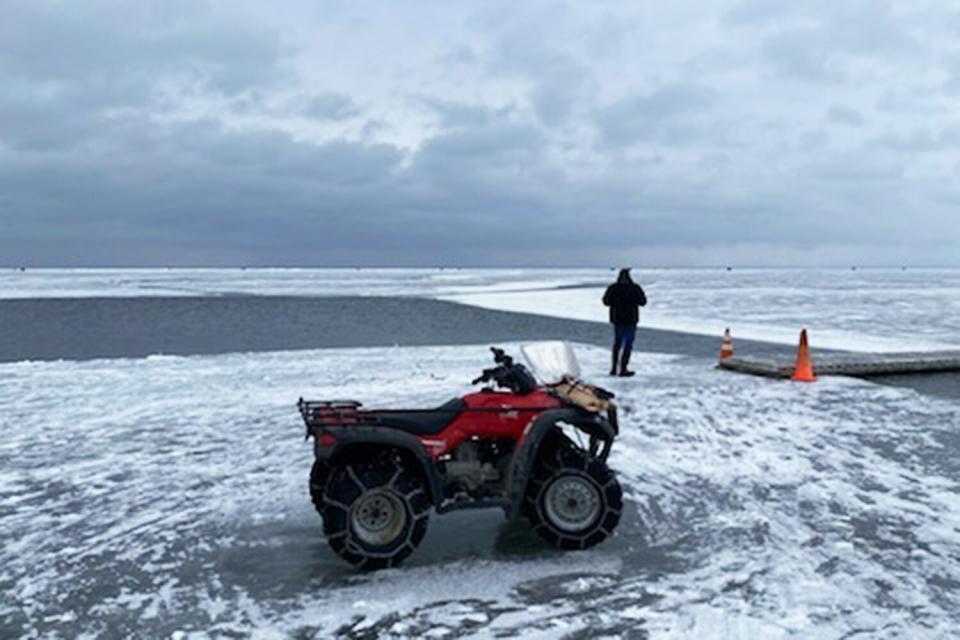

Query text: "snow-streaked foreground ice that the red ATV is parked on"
[0, 346, 960, 638]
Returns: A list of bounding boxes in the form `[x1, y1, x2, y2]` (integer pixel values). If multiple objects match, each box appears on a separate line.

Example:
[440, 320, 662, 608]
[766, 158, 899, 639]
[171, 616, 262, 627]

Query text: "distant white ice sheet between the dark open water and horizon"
[0, 269, 960, 351]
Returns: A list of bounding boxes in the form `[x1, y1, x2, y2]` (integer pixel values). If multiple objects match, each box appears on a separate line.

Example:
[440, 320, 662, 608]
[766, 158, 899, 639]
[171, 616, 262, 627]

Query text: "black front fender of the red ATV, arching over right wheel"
[506, 407, 616, 518]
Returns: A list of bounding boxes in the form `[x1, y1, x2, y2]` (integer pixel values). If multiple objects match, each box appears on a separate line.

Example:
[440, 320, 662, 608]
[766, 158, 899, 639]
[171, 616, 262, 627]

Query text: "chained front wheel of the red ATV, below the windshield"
[524, 440, 623, 550]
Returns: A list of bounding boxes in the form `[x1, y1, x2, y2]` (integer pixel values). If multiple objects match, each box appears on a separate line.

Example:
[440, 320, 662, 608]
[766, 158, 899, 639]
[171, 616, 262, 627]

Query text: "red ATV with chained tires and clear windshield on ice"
[298, 343, 623, 569]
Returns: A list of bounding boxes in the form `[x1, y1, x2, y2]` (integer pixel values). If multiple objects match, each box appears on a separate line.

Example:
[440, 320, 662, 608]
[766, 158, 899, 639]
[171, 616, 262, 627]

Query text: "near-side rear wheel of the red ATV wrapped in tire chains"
[321, 457, 430, 570]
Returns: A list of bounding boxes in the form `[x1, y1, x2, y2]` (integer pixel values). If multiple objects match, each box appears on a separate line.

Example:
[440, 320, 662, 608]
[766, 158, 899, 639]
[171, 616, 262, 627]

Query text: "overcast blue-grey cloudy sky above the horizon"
[0, 0, 960, 266]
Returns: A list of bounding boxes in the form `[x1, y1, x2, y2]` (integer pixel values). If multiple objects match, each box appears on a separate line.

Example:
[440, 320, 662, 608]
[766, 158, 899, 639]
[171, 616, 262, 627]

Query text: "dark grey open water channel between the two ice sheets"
[0, 296, 960, 398]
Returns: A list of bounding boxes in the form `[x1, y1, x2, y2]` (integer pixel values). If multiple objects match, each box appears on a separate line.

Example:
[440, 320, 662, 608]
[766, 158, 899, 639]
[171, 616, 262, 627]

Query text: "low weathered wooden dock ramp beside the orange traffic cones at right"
[718, 351, 960, 378]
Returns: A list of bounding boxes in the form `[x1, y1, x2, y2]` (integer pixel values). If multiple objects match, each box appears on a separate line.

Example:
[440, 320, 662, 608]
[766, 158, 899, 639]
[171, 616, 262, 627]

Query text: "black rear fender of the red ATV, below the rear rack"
[314, 426, 443, 506]
